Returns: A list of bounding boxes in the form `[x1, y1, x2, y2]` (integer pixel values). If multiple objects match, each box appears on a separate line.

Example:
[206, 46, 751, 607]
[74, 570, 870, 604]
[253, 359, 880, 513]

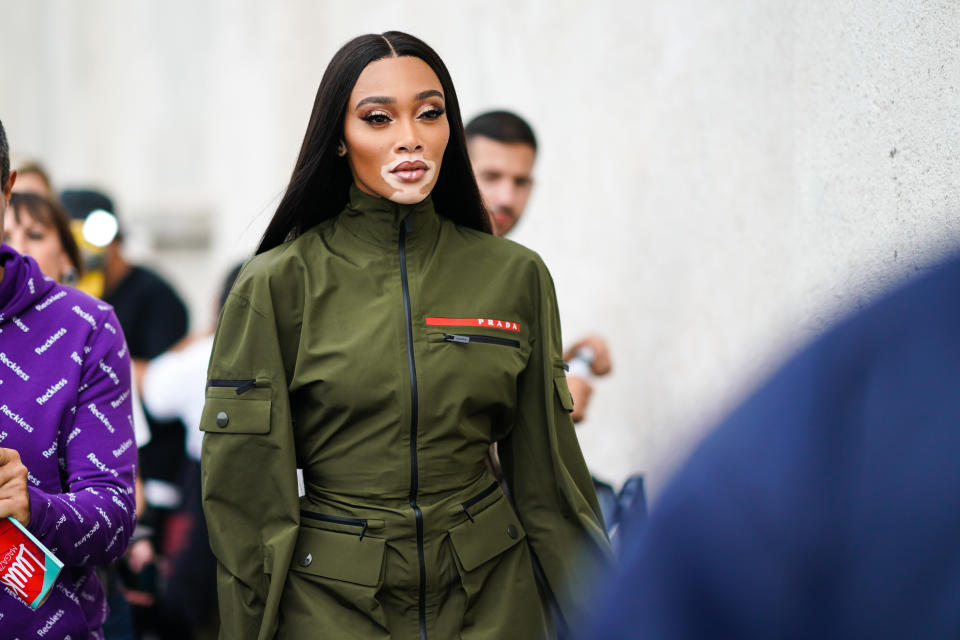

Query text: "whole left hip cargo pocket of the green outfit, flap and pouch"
[277, 525, 390, 638]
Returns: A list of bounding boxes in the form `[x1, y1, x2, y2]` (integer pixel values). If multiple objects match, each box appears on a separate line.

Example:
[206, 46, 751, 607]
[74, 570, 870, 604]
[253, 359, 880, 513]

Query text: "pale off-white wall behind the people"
[0, 0, 960, 492]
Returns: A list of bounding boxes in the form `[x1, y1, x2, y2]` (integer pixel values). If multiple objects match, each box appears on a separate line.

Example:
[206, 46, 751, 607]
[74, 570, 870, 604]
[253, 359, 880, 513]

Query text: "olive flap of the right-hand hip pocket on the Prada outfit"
[450, 497, 526, 571]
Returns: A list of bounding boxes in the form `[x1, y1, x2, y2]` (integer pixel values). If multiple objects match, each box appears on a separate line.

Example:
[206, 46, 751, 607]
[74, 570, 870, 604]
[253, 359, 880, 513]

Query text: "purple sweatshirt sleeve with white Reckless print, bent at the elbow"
[28, 310, 137, 567]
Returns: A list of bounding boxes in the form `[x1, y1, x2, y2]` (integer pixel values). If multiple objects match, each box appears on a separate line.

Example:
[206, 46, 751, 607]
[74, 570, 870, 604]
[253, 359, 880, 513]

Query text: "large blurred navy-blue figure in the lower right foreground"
[581, 252, 960, 640]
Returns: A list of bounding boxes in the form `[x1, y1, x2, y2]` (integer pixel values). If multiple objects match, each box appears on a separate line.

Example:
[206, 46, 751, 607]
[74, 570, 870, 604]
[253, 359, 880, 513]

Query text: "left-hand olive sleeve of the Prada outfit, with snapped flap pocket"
[200, 275, 299, 640]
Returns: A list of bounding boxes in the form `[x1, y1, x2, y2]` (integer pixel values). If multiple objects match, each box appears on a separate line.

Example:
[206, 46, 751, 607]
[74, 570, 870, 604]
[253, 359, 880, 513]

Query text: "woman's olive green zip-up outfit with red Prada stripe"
[201, 187, 608, 640]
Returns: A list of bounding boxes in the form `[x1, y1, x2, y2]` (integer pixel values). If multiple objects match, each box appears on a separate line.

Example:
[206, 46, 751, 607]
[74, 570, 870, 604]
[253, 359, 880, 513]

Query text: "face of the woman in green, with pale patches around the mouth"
[343, 56, 450, 204]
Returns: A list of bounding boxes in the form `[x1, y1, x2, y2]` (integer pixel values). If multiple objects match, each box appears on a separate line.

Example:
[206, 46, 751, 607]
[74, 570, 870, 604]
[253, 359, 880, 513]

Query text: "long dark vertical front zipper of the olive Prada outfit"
[399, 215, 427, 640]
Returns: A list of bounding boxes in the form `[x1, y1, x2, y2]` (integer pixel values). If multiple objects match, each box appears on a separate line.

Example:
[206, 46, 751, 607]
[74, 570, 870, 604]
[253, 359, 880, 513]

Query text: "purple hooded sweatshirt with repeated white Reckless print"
[0, 245, 137, 640]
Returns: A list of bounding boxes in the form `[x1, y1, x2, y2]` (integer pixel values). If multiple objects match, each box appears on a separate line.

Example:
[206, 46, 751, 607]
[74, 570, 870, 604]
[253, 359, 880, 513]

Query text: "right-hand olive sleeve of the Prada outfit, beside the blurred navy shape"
[499, 261, 611, 623]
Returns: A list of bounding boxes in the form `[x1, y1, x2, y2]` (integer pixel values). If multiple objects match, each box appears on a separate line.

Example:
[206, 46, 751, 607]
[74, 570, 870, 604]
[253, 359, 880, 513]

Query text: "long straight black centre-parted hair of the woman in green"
[257, 31, 490, 253]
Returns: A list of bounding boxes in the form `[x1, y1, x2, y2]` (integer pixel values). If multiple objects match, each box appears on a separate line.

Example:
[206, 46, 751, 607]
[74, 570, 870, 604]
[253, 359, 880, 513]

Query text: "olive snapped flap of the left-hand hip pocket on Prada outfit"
[290, 526, 384, 587]
